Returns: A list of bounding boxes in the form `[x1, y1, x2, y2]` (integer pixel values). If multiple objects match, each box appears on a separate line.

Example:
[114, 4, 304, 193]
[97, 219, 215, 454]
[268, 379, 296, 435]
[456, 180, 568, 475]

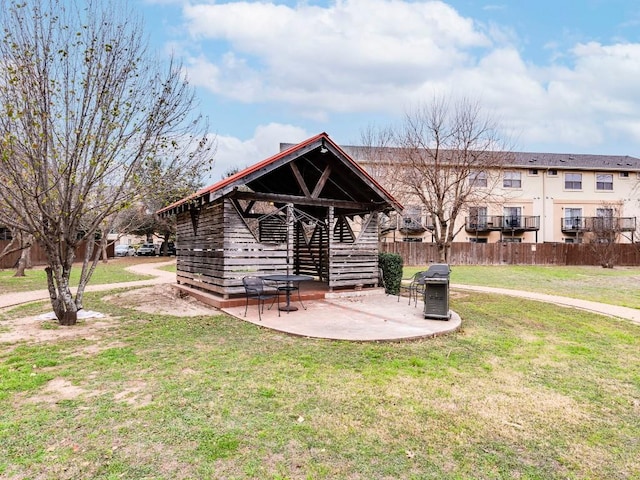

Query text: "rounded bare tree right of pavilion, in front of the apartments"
[362, 98, 511, 262]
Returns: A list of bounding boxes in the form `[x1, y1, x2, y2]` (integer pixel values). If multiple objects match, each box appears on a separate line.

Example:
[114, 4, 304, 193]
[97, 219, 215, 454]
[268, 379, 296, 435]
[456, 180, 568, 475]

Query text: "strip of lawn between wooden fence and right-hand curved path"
[403, 265, 640, 308]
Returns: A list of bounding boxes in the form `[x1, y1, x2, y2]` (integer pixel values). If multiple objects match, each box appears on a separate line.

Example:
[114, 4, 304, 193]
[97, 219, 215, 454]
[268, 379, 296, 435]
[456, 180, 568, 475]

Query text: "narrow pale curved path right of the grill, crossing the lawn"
[451, 283, 640, 325]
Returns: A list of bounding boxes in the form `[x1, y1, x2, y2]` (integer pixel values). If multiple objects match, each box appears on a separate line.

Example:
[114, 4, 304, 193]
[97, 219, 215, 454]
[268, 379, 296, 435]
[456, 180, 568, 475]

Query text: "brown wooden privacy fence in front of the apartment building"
[379, 242, 640, 266]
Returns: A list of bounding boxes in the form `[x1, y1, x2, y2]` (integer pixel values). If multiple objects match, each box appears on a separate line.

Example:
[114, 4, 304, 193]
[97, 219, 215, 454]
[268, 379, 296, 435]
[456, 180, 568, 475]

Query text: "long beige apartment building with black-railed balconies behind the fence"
[344, 147, 640, 243]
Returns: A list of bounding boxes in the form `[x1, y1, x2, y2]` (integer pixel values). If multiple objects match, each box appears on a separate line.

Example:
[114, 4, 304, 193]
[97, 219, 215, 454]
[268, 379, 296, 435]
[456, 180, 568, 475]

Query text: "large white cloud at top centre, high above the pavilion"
[184, 0, 490, 109]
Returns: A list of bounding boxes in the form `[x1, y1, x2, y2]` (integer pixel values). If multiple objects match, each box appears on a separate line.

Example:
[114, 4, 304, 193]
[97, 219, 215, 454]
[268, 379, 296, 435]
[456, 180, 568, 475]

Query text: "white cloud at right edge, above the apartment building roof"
[516, 43, 640, 151]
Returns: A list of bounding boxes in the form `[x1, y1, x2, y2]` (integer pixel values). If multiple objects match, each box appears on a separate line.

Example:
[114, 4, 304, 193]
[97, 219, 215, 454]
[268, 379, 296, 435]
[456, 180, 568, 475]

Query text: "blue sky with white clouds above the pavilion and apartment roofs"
[138, 0, 640, 181]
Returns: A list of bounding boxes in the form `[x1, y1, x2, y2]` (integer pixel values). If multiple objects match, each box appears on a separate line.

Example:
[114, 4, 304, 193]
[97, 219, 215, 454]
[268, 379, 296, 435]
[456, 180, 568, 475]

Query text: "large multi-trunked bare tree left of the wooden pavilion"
[0, 0, 215, 325]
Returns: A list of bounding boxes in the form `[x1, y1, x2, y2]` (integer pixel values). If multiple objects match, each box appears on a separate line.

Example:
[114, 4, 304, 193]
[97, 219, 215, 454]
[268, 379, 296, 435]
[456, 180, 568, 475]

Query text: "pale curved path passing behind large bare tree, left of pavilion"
[0, 260, 176, 308]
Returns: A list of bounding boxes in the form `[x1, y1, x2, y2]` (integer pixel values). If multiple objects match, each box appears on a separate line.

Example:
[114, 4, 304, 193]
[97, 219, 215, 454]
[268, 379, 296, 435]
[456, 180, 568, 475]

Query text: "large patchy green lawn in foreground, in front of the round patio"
[0, 284, 640, 480]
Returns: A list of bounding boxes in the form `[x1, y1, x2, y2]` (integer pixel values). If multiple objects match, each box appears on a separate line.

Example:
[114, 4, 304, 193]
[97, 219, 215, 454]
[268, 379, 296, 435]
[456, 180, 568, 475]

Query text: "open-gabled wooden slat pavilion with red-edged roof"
[158, 133, 402, 299]
